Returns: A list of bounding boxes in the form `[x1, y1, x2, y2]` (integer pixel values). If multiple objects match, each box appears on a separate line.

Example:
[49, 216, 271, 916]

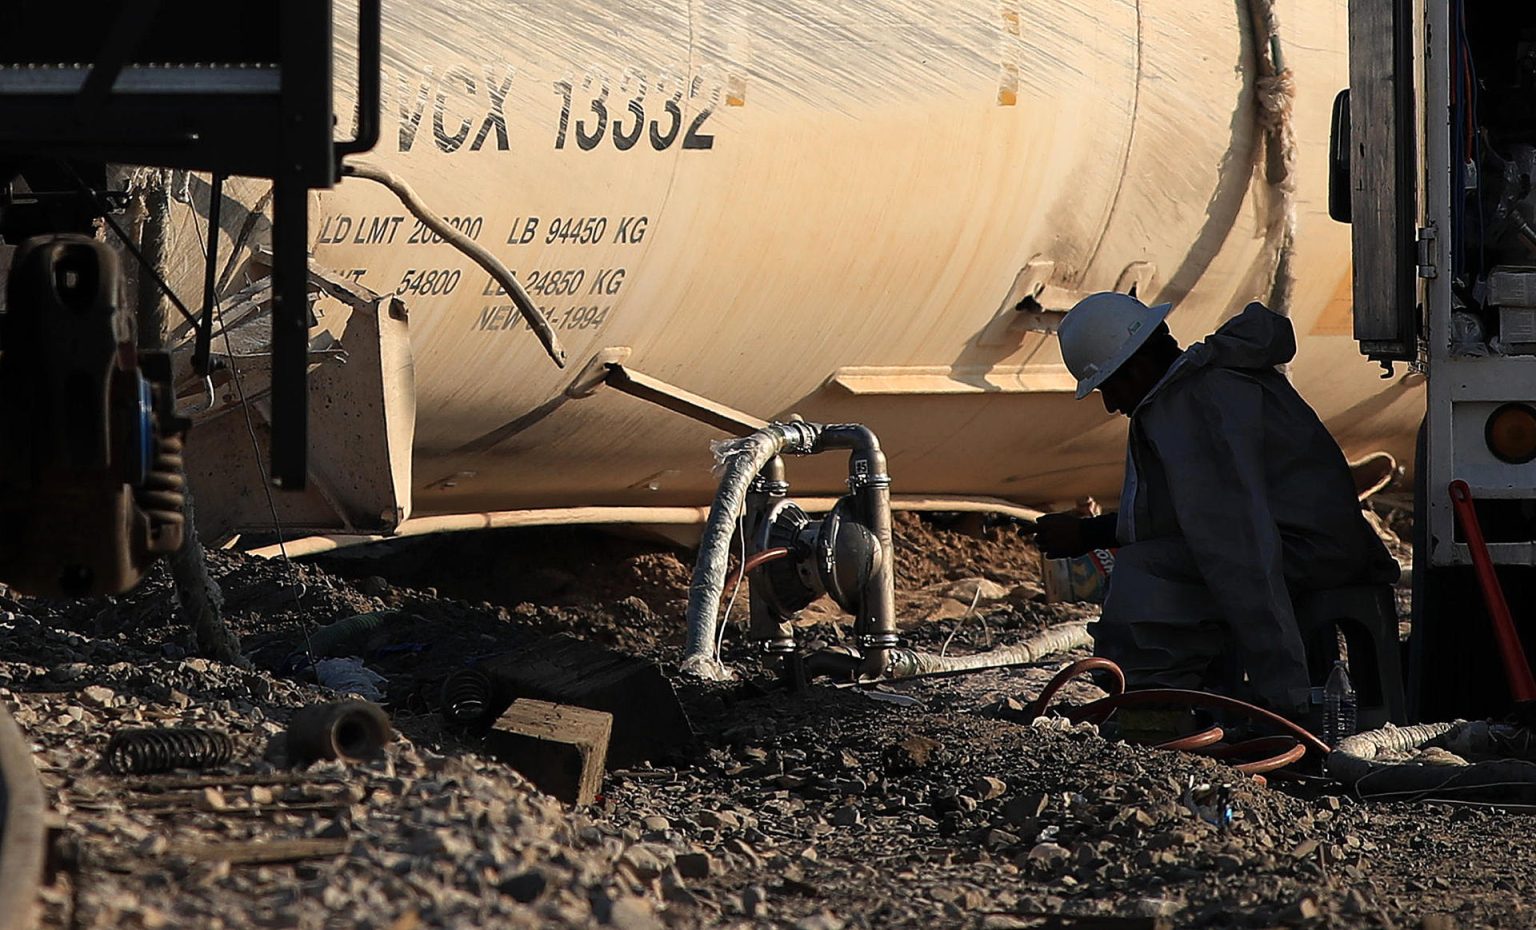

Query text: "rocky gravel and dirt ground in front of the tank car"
[0, 516, 1536, 930]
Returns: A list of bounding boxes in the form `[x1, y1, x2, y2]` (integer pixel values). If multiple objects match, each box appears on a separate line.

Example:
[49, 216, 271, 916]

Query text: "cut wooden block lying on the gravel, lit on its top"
[485, 698, 613, 805]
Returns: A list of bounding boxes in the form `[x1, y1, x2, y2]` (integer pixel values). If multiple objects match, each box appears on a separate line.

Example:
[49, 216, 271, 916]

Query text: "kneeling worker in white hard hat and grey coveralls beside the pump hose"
[1037, 294, 1398, 716]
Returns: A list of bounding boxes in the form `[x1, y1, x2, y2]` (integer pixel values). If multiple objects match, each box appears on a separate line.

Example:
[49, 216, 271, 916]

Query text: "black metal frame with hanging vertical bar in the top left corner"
[0, 0, 381, 489]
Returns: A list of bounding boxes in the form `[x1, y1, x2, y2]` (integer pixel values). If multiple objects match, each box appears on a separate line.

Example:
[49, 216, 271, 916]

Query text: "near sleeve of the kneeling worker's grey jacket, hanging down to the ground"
[1143, 369, 1309, 709]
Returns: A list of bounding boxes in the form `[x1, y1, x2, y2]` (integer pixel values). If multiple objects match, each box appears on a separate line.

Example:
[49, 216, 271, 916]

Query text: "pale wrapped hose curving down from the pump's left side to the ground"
[679, 423, 822, 681]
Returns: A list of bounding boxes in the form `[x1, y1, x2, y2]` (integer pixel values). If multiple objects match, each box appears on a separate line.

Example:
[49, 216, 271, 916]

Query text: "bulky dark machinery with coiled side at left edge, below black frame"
[0, 235, 187, 596]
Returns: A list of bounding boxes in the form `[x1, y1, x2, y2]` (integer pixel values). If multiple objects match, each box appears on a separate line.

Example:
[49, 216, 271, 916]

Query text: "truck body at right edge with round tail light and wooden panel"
[1332, 0, 1536, 719]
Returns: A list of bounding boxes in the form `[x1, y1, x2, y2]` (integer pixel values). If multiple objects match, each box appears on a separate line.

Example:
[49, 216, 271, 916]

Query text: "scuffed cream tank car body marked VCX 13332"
[149, 0, 1422, 535]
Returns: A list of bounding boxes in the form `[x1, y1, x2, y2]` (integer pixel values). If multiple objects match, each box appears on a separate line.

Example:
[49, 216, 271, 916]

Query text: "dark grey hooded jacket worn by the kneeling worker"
[1112, 303, 1398, 704]
